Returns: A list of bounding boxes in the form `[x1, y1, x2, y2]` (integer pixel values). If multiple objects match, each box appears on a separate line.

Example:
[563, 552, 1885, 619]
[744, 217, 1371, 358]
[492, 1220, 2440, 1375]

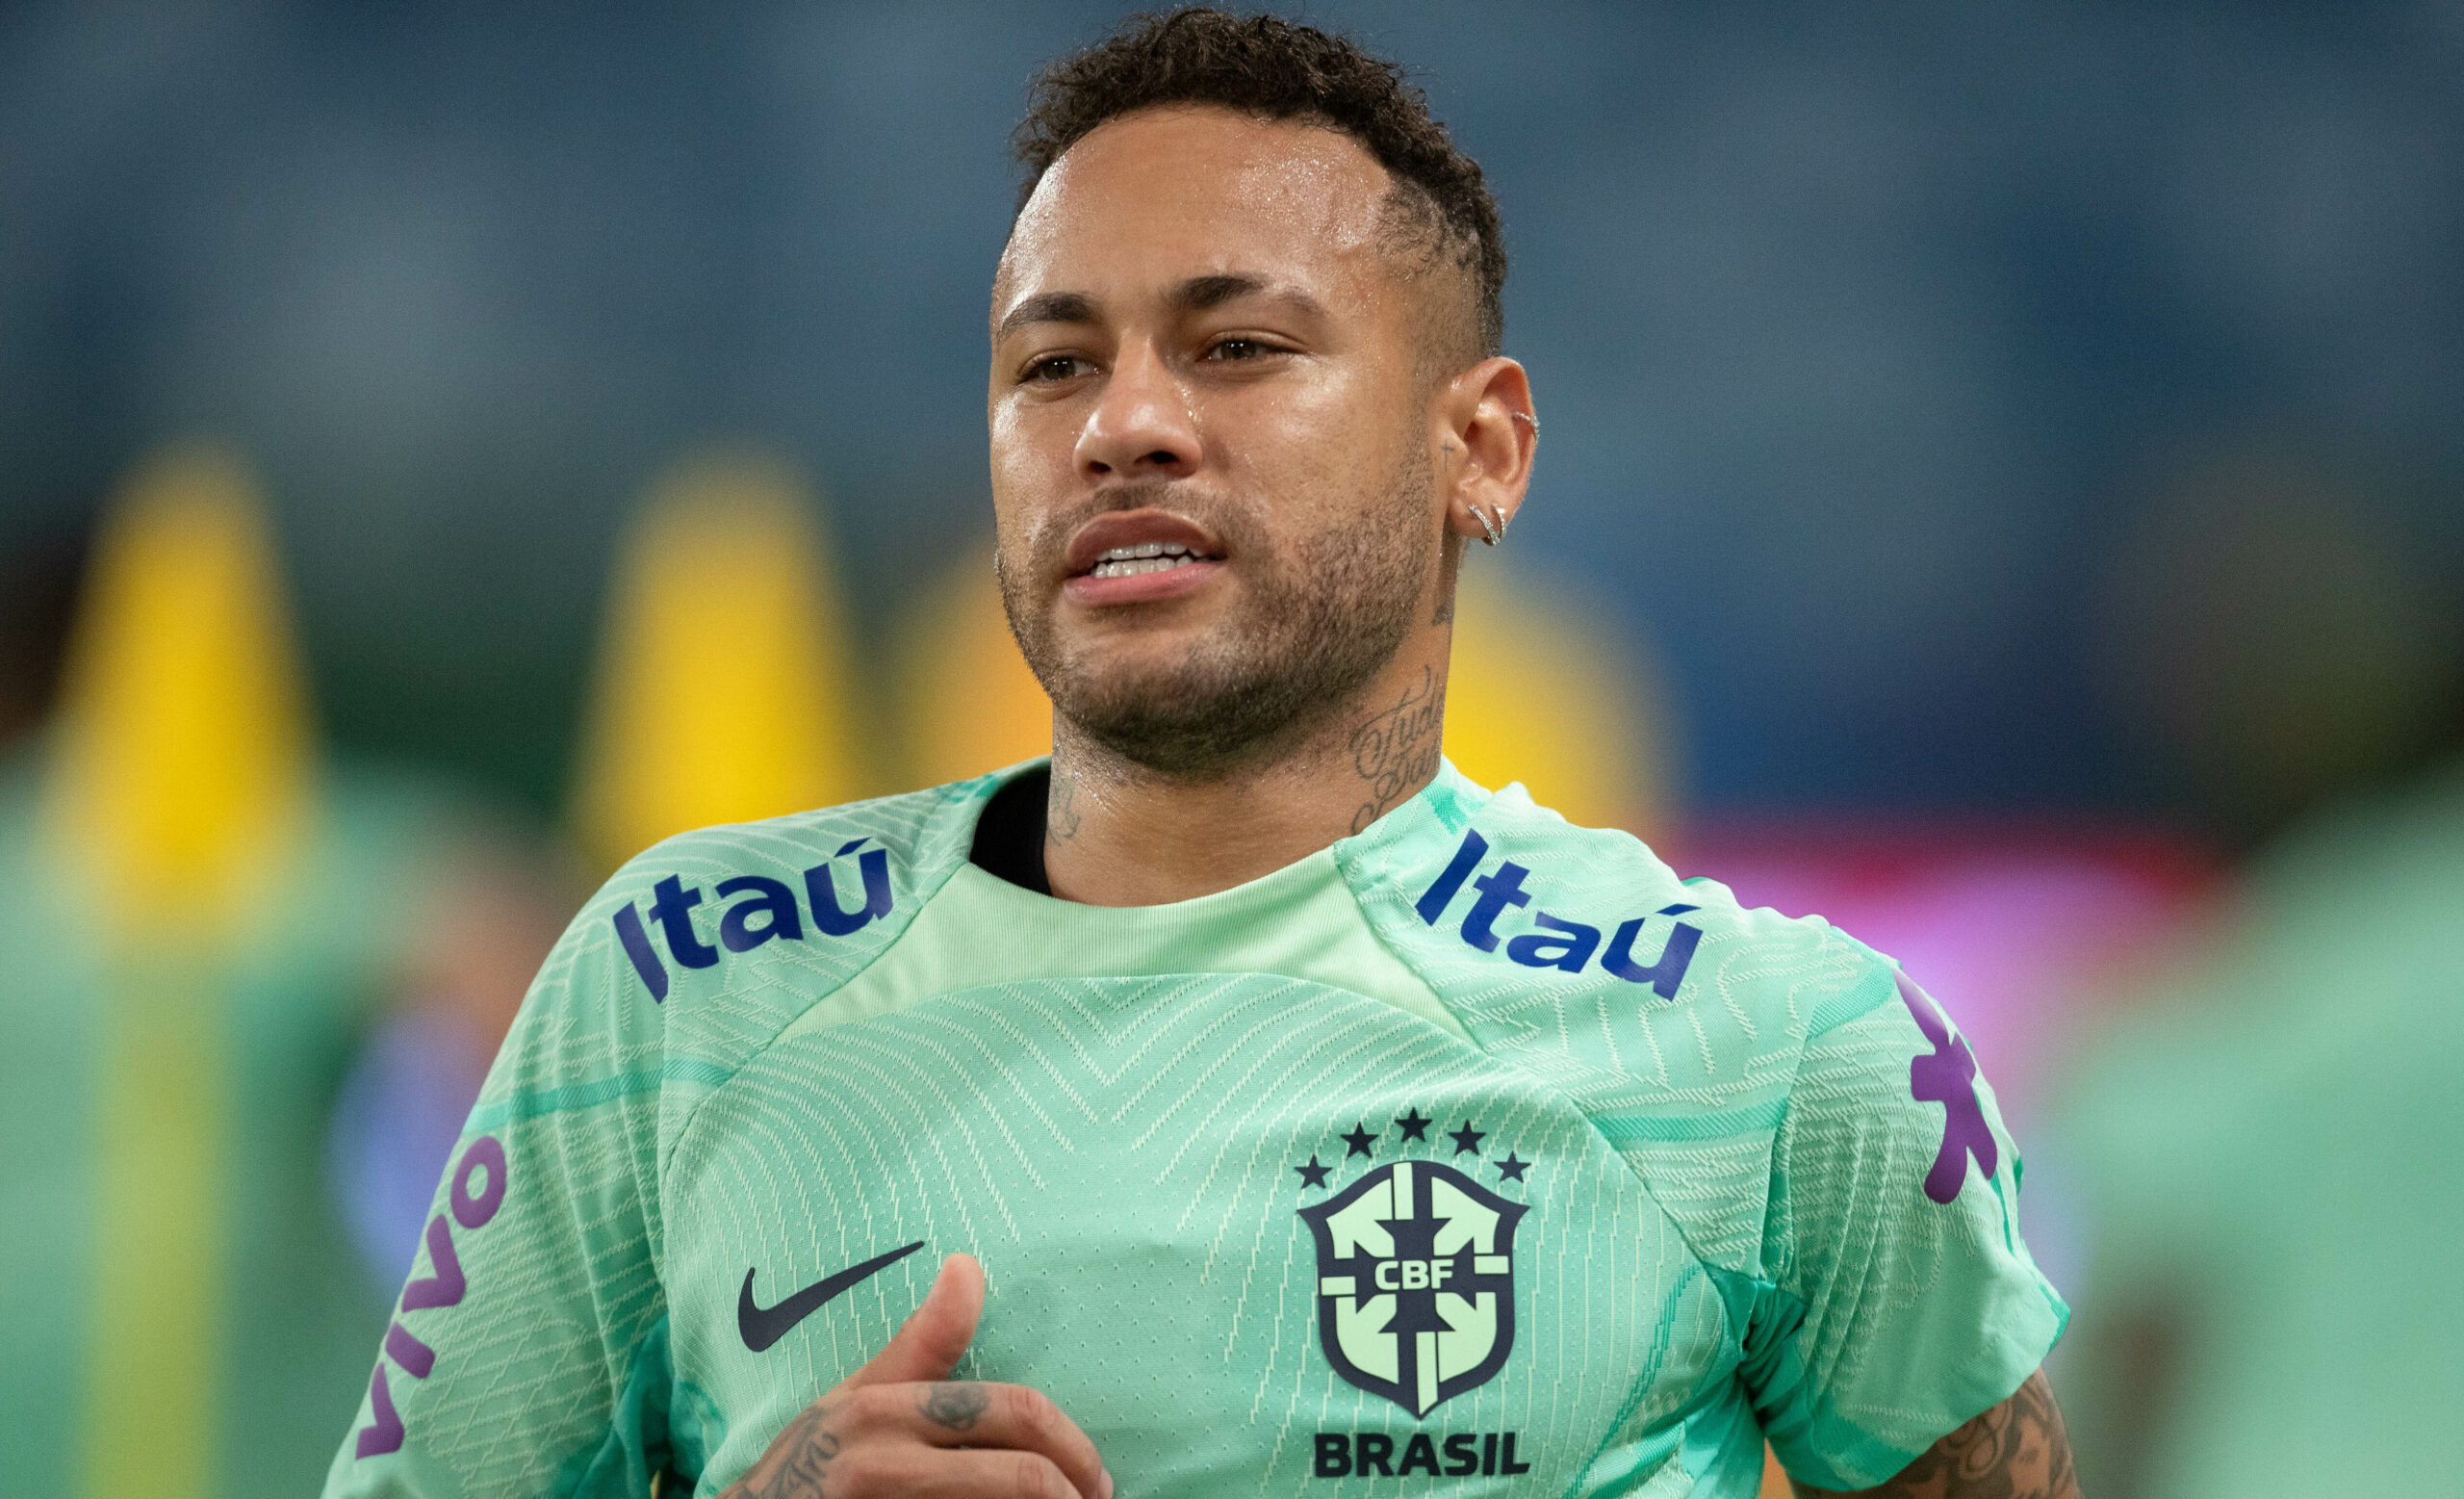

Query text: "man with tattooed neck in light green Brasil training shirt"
[327, 10, 2072, 1499]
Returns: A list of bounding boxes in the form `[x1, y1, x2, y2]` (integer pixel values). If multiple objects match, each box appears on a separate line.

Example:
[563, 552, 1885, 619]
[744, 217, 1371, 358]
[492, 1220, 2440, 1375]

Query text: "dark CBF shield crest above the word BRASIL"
[1301, 1122, 1526, 1415]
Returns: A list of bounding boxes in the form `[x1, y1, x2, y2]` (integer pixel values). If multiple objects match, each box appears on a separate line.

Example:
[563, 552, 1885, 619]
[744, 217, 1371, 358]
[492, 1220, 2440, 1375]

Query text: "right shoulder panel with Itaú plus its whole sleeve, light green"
[1338, 774, 2067, 1489]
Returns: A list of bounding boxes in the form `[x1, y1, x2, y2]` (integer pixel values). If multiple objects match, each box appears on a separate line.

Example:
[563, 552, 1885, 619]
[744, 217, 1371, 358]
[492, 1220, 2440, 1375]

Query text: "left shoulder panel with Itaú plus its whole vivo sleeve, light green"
[327, 782, 988, 1494]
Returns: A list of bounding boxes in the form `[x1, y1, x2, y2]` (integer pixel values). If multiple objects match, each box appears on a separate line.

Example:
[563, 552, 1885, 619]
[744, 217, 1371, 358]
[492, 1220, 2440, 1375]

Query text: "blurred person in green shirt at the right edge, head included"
[2058, 452, 2464, 1499]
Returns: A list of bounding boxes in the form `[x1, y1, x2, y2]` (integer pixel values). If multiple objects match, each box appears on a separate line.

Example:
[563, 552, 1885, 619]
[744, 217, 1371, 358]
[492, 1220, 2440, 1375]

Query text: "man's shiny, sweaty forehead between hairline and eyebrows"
[993, 106, 1392, 323]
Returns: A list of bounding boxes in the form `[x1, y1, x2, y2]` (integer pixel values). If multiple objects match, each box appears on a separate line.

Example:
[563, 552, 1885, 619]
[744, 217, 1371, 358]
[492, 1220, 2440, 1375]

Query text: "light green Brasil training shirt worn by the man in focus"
[327, 766, 2067, 1499]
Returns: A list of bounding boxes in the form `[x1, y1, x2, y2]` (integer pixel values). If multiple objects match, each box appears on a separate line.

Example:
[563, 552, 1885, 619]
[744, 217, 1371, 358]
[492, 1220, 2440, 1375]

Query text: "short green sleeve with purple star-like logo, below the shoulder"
[1744, 974, 2069, 1489]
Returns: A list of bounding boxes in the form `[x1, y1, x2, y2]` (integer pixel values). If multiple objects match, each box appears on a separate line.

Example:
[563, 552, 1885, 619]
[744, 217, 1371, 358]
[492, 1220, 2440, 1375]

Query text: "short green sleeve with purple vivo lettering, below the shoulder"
[325, 900, 670, 1499]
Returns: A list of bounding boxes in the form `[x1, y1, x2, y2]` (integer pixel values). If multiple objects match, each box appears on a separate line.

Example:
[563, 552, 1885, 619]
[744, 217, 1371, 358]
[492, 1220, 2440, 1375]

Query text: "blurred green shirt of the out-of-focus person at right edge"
[2063, 764, 2464, 1499]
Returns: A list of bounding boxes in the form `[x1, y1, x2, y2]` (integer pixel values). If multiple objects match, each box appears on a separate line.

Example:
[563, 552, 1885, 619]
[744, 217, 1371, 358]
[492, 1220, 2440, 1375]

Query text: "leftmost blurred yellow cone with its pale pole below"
[47, 444, 311, 1499]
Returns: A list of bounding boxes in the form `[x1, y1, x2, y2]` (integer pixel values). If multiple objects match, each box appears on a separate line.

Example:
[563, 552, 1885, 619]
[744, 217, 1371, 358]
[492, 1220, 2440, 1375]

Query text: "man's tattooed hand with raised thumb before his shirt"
[720, 1254, 1112, 1499]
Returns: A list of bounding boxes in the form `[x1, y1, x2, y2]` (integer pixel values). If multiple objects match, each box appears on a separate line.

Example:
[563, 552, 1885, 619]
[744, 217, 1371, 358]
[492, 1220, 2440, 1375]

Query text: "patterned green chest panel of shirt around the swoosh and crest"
[668, 974, 1722, 1494]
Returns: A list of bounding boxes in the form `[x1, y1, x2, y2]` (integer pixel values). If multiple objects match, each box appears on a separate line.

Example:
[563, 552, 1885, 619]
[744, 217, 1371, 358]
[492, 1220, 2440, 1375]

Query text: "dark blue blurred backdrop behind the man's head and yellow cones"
[0, 3, 2464, 814]
